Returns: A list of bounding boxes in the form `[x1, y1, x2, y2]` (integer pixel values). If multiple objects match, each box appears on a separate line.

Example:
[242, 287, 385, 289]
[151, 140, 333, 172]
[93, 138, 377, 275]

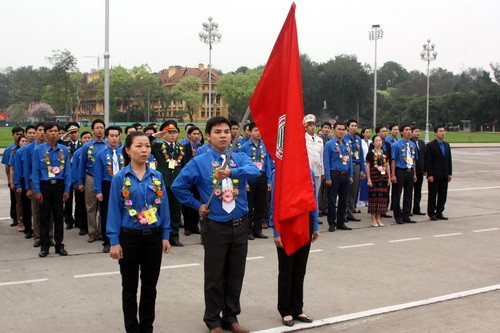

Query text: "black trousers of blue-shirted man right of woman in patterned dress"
[392, 168, 414, 222]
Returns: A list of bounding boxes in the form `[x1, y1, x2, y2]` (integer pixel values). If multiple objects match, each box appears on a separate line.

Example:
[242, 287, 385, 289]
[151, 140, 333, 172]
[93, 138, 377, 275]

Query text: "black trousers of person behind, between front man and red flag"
[247, 174, 268, 235]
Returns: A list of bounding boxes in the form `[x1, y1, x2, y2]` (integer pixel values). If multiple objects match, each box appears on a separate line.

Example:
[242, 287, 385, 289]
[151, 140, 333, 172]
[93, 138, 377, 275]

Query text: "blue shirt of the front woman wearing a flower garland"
[106, 165, 171, 245]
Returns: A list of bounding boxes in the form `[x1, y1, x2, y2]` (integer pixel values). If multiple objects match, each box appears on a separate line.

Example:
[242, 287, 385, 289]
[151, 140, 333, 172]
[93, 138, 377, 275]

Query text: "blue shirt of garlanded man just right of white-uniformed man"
[323, 137, 353, 180]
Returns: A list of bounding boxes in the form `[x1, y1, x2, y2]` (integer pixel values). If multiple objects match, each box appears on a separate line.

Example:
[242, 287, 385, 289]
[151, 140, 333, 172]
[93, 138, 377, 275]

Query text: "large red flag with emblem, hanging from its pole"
[249, 3, 316, 255]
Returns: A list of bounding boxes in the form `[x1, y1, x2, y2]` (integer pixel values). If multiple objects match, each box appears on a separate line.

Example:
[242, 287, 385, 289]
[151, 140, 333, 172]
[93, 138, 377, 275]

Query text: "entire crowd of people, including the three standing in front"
[2, 115, 452, 333]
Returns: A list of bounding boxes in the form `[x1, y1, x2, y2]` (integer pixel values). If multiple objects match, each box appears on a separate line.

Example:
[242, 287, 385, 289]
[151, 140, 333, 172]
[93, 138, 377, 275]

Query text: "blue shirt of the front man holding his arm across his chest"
[171, 149, 260, 222]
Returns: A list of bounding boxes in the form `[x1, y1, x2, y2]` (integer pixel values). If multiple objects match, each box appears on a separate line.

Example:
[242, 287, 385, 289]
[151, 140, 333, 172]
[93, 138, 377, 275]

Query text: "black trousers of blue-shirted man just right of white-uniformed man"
[327, 172, 349, 228]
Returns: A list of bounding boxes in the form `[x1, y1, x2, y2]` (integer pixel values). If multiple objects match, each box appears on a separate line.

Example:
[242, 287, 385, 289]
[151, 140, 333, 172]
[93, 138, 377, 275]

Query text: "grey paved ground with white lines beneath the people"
[0, 148, 500, 333]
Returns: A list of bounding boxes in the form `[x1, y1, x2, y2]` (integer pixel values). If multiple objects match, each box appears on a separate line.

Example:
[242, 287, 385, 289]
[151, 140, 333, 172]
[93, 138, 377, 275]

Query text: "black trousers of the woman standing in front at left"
[119, 232, 163, 333]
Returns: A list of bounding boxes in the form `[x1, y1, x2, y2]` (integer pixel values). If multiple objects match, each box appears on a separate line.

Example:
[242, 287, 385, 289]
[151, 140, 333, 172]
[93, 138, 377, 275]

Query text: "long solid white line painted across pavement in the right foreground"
[255, 284, 500, 333]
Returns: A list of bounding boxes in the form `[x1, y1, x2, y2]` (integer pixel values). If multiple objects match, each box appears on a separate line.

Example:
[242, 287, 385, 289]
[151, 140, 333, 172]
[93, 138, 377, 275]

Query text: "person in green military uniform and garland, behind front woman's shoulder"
[149, 120, 186, 246]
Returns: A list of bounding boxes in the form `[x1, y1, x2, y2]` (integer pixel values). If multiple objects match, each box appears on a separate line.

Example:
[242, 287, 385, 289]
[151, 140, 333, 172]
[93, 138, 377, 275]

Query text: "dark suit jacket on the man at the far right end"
[425, 139, 452, 179]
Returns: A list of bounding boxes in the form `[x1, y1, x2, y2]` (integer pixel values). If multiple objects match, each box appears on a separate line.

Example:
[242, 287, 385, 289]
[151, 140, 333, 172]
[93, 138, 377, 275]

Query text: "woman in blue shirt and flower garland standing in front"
[106, 131, 170, 332]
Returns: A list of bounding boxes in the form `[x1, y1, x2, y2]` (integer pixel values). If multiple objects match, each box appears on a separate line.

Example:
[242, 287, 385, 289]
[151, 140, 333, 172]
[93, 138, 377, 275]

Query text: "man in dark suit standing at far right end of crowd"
[425, 125, 452, 221]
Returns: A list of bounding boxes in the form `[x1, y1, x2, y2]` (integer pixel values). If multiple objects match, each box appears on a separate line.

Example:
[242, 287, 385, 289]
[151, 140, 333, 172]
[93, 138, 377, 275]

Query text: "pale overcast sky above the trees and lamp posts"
[0, 0, 500, 73]
